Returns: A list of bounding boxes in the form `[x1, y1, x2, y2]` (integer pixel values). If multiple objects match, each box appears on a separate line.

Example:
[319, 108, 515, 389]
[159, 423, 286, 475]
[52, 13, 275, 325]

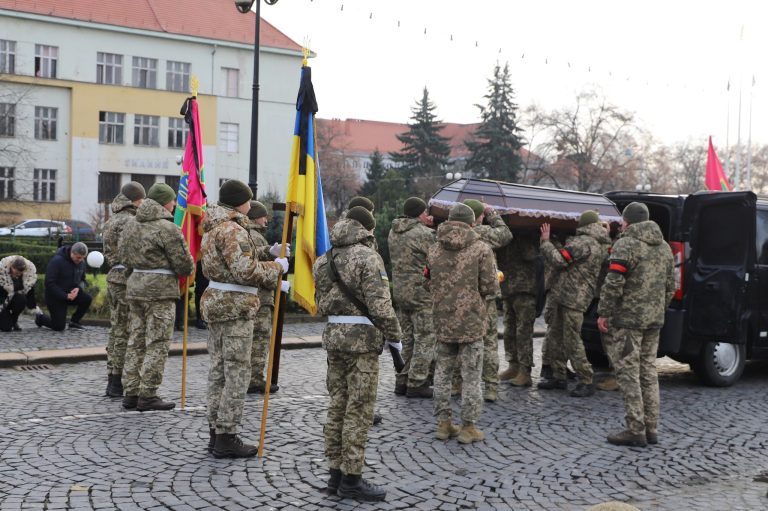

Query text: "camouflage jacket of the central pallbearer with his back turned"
[426, 222, 499, 343]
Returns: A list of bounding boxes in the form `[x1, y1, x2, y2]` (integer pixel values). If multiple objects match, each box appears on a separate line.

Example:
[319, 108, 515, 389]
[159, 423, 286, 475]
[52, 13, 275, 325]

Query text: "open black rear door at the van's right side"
[683, 192, 757, 343]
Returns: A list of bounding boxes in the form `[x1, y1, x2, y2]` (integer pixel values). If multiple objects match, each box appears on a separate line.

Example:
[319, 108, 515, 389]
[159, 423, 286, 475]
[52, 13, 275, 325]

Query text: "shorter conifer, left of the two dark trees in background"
[390, 87, 451, 183]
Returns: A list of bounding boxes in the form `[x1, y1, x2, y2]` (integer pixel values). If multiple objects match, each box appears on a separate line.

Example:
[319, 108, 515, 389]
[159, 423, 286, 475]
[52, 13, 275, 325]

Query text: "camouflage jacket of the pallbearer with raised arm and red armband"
[541, 223, 610, 312]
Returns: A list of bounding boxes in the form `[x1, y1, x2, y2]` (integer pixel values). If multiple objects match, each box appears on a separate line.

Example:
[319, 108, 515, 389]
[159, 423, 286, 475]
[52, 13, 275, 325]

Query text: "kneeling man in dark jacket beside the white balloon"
[35, 241, 92, 332]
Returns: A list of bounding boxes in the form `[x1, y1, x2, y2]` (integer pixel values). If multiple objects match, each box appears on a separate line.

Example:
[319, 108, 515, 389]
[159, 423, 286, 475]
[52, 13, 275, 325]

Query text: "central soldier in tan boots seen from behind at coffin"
[426, 203, 499, 444]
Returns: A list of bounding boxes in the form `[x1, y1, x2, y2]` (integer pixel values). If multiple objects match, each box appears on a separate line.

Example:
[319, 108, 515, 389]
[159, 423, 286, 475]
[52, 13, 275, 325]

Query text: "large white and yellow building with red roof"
[0, 0, 302, 225]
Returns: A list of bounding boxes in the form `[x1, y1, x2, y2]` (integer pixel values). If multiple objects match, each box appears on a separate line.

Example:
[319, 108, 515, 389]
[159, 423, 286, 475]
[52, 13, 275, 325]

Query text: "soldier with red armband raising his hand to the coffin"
[538, 210, 610, 397]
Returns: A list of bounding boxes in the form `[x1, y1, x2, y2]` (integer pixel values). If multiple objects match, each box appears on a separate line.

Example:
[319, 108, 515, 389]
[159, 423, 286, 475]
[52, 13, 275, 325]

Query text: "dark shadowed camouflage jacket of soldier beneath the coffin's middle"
[496, 235, 539, 297]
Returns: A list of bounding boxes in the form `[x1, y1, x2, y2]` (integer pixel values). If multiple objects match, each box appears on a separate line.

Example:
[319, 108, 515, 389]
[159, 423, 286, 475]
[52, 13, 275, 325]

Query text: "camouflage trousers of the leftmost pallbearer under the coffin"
[395, 309, 435, 387]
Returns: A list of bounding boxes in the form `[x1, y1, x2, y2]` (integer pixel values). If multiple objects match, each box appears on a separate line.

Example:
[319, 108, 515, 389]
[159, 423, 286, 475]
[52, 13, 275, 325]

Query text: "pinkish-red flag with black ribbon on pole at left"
[174, 96, 206, 289]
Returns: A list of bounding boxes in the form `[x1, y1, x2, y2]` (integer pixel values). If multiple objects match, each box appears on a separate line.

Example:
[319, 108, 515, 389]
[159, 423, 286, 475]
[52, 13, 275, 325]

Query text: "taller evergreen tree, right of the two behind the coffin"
[466, 64, 523, 182]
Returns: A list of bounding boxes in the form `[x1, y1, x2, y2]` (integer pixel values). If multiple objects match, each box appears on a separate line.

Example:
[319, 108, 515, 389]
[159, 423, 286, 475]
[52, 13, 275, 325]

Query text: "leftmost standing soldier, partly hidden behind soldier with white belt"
[104, 181, 147, 397]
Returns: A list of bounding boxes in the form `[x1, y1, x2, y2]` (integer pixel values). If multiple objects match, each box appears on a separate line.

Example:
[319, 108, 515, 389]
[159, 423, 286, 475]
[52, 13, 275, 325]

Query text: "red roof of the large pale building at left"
[0, 0, 301, 51]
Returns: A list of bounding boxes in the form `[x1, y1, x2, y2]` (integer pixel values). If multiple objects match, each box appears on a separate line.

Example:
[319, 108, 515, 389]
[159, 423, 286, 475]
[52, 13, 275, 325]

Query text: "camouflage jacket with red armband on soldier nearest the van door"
[597, 221, 675, 329]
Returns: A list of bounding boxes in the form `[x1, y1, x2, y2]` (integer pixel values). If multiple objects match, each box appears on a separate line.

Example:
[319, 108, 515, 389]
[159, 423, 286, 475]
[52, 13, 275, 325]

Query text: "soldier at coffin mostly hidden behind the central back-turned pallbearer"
[464, 199, 512, 402]
